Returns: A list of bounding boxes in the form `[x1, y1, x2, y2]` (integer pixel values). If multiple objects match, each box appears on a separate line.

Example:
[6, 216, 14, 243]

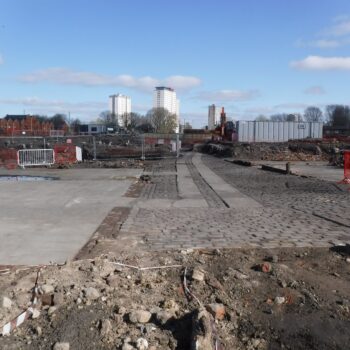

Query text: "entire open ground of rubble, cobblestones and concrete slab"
[0, 153, 350, 350]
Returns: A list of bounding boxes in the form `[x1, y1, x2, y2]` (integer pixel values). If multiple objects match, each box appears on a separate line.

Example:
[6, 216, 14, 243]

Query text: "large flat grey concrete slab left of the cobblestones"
[0, 169, 142, 265]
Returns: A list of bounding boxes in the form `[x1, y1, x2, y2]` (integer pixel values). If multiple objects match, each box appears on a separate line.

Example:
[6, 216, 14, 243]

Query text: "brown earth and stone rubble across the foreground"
[0, 248, 350, 350]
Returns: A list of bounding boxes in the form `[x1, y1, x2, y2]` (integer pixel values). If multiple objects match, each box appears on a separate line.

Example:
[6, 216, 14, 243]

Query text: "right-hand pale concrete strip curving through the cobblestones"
[192, 153, 262, 209]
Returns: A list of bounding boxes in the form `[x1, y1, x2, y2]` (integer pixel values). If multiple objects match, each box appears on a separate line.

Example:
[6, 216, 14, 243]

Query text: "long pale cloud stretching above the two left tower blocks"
[19, 67, 201, 91]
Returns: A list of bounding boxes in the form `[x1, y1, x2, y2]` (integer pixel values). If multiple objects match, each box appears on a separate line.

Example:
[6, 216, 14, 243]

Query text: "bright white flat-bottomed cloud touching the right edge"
[290, 56, 350, 70]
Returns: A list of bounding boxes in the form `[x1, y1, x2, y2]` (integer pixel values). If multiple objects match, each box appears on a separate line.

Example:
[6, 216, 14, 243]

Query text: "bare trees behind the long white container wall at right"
[255, 105, 350, 128]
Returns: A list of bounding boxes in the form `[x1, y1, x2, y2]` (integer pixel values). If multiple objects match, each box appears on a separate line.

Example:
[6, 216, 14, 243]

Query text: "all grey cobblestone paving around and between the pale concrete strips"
[120, 155, 350, 250]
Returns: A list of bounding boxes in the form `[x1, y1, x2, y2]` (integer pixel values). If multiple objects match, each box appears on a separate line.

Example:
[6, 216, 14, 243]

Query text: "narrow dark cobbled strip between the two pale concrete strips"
[185, 155, 227, 208]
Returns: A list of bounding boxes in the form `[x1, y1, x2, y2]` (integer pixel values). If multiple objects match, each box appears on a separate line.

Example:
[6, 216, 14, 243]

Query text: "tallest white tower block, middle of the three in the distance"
[153, 86, 180, 132]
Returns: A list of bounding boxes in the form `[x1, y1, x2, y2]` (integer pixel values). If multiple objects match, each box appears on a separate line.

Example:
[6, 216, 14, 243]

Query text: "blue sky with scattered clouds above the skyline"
[0, 0, 350, 127]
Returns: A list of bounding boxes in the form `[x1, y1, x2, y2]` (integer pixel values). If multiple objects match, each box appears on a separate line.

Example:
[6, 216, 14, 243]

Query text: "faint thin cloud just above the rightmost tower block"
[196, 90, 260, 103]
